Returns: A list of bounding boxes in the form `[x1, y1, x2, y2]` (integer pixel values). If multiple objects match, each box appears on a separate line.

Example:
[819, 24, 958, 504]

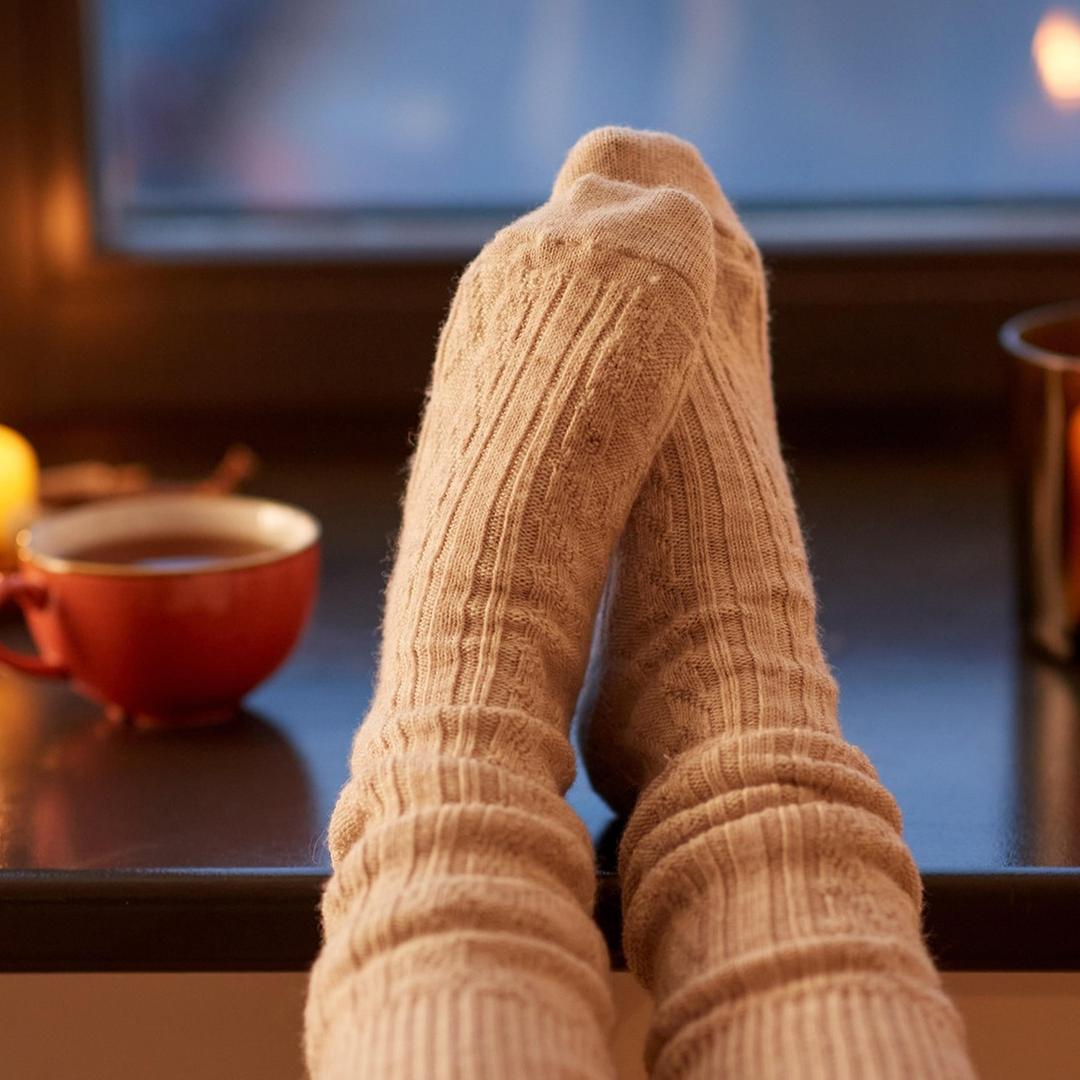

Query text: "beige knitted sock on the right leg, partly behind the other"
[574, 130, 972, 1080]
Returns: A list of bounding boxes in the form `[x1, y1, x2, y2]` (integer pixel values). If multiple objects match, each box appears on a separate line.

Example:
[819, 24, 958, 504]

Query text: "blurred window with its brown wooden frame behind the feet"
[0, 0, 1080, 440]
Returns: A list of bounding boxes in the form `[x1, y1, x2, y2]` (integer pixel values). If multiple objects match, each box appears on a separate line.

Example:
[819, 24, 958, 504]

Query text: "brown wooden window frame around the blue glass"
[0, 0, 1080, 438]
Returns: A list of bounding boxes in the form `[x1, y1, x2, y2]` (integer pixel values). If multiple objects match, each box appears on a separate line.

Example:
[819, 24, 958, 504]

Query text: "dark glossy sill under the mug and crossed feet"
[0, 415, 1080, 971]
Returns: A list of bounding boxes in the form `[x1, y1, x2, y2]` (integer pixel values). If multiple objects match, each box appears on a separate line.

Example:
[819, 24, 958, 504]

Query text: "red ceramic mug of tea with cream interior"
[0, 495, 320, 725]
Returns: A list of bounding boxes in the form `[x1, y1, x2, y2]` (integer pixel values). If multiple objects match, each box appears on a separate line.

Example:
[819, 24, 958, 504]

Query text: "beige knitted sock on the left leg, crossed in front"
[307, 143, 714, 1080]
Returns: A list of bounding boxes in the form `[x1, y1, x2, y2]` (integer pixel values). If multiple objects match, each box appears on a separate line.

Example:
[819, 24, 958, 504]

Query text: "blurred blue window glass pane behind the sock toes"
[87, 0, 1080, 251]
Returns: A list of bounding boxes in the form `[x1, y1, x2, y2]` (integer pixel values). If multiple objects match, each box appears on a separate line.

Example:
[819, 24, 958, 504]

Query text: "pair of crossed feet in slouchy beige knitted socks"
[307, 129, 970, 1080]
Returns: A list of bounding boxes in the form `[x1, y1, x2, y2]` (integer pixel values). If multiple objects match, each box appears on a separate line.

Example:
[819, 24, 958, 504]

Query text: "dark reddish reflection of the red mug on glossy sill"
[29, 713, 319, 869]
